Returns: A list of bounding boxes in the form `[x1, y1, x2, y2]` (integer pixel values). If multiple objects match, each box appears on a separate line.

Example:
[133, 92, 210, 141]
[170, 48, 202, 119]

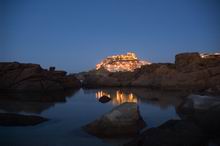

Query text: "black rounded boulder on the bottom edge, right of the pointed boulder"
[125, 120, 207, 146]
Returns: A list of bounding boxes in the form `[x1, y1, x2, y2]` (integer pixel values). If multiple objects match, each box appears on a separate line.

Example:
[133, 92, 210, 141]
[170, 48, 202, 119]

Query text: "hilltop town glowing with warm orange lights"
[96, 52, 150, 72]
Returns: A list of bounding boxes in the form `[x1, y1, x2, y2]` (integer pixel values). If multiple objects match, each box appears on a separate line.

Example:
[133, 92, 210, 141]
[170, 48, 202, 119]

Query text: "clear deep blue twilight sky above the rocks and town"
[0, 0, 220, 72]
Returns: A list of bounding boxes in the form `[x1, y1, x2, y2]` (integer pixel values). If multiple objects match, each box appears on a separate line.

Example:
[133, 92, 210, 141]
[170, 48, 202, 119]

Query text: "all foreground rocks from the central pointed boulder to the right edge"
[83, 94, 220, 146]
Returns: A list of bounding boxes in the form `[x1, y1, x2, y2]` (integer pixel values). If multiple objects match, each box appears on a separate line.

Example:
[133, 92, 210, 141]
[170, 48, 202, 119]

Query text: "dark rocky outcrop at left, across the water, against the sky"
[0, 62, 80, 91]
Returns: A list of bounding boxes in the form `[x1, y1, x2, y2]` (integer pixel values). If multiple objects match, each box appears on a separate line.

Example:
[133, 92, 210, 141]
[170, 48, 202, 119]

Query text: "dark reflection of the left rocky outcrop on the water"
[0, 90, 77, 114]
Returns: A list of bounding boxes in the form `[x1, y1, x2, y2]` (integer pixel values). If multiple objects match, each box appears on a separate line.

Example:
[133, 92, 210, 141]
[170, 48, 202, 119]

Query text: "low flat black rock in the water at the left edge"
[0, 113, 48, 126]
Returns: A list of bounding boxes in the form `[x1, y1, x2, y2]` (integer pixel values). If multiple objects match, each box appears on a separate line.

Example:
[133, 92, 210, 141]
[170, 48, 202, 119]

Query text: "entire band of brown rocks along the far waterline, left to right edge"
[0, 53, 220, 93]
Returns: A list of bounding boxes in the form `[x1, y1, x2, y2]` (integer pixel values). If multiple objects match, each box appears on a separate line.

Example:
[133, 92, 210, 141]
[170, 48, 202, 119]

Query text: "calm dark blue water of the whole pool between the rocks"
[0, 88, 186, 146]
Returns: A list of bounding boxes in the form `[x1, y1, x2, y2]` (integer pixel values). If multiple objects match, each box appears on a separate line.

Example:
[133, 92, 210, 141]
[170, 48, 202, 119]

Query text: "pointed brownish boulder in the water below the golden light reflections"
[83, 103, 146, 138]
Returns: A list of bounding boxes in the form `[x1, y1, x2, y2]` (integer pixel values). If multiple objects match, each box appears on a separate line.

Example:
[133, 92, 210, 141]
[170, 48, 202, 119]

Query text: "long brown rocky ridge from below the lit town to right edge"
[77, 53, 220, 93]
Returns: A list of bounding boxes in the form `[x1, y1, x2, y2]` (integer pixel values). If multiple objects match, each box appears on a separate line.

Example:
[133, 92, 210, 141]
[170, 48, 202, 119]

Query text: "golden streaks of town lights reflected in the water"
[96, 90, 138, 105]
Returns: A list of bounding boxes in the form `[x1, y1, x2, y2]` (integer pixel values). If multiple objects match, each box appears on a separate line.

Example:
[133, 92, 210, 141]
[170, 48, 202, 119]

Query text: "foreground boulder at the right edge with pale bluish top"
[176, 95, 220, 136]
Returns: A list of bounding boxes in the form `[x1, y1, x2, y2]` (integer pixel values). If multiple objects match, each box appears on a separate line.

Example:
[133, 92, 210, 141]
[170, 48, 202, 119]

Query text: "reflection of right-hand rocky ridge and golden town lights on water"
[89, 88, 189, 109]
